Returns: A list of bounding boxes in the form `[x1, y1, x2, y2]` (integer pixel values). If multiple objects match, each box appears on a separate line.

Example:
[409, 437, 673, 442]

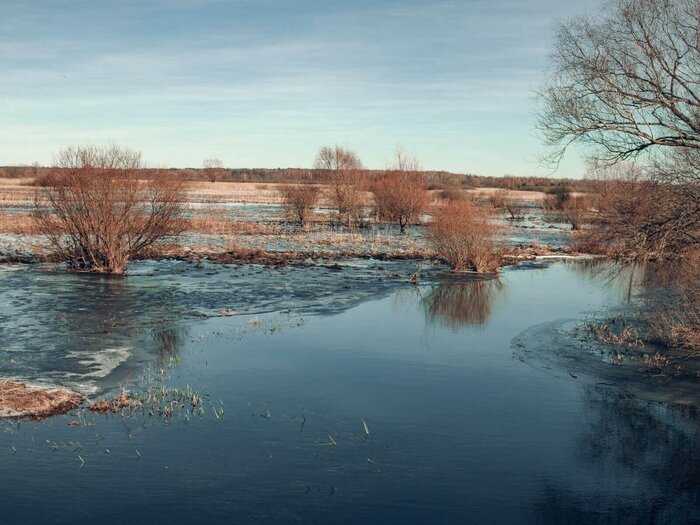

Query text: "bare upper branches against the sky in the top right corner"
[539, 0, 700, 162]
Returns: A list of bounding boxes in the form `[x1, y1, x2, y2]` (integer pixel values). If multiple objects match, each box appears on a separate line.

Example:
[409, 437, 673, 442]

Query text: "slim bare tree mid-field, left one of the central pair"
[314, 145, 366, 226]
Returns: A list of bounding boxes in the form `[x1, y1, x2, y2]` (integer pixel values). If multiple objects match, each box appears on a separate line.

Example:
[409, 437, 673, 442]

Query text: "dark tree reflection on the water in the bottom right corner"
[533, 382, 700, 524]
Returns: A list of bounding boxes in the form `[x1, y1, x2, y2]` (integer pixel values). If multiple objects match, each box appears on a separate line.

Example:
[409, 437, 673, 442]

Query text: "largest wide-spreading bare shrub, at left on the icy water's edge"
[34, 146, 183, 274]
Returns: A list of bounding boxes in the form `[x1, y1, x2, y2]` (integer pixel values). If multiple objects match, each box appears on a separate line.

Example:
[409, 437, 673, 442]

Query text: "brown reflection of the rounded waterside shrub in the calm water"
[422, 278, 506, 329]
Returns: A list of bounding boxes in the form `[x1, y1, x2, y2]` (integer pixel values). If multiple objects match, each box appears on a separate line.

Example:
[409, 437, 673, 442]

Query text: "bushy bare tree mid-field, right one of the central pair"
[371, 148, 430, 233]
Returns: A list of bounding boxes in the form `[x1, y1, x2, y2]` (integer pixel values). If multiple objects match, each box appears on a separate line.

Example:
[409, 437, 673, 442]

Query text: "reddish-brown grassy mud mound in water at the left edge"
[0, 381, 83, 420]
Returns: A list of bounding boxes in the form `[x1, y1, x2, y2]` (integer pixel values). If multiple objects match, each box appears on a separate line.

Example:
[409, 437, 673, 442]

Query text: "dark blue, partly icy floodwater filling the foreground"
[0, 261, 700, 524]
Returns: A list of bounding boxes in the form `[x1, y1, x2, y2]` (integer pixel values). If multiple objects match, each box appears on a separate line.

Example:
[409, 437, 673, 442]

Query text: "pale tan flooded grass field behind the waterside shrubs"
[0, 178, 580, 264]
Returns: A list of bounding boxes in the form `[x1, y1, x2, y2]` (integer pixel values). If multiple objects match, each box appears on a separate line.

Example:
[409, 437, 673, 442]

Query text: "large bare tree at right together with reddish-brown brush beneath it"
[539, 0, 700, 258]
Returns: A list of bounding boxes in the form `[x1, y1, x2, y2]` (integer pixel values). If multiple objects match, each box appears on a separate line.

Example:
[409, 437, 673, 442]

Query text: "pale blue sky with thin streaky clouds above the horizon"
[0, 0, 599, 177]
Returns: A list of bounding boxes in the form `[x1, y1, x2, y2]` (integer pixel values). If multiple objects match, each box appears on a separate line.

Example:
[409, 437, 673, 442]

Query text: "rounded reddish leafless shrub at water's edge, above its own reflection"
[428, 201, 501, 272]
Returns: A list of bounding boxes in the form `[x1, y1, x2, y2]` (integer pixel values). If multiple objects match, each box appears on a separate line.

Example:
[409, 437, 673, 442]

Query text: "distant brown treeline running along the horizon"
[0, 165, 593, 193]
